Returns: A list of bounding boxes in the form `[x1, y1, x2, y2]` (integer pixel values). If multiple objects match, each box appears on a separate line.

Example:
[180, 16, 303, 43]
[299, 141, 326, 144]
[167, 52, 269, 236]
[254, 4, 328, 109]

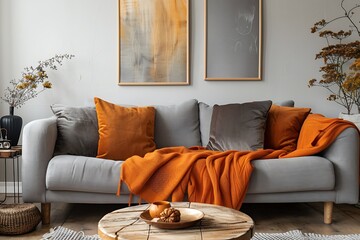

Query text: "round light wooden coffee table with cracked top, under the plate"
[98, 202, 254, 240]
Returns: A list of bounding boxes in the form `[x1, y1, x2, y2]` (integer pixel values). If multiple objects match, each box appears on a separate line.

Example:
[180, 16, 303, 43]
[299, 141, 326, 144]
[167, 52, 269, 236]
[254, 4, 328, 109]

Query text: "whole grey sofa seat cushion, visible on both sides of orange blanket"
[46, 155, 335, 197]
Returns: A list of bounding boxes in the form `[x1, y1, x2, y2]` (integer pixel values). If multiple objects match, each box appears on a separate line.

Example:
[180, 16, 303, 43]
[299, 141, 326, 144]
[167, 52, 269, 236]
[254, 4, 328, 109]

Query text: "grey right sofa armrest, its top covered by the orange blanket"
[321, 128, 359, 203]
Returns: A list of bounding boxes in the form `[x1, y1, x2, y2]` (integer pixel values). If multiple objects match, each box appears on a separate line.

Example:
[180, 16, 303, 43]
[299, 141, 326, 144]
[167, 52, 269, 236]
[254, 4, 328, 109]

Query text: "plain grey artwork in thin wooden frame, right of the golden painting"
[204, 0, 262, 80]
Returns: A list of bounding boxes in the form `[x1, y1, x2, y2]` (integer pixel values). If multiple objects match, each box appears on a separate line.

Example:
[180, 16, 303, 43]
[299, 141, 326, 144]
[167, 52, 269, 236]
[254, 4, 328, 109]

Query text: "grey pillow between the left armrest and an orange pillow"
[51, 104, 99, 157]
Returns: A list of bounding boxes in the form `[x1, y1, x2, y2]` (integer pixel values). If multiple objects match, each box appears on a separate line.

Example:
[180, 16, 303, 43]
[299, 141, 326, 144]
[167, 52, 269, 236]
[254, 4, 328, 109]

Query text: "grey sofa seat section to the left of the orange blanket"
[46, 155, 130, 194]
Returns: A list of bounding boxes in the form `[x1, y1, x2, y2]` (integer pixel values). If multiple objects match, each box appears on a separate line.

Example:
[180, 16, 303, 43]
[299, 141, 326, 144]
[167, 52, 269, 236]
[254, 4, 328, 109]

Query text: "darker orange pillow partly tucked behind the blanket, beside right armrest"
[264, 104, 311, 152]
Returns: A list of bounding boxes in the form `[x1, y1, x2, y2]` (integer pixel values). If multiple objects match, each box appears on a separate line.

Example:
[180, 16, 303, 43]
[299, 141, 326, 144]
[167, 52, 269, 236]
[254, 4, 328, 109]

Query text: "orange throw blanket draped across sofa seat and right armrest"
[118, 114, 356, 209]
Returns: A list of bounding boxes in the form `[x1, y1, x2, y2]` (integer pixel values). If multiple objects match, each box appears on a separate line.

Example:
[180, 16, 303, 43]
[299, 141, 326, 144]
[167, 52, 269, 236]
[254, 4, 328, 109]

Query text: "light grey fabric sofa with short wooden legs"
[22, 100, 359, 224]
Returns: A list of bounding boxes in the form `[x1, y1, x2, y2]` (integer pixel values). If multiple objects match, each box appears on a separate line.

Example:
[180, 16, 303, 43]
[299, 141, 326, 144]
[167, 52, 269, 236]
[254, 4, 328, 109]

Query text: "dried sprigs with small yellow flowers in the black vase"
[1, 54, 74, 107]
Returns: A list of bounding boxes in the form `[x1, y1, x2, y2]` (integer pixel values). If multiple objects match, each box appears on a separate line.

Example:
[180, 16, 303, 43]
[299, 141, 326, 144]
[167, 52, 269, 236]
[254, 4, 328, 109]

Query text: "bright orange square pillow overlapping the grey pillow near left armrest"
[94, 97, 156, 160]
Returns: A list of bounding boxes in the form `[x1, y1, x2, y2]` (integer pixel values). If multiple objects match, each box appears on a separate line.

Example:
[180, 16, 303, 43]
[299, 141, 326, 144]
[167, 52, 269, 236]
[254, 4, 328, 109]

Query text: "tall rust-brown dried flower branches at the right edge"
[308, 0, 360, 114]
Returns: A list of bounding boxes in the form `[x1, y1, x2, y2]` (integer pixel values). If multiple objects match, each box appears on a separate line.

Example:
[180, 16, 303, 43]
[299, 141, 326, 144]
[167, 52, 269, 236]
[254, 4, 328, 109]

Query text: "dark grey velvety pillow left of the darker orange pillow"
[206, 101, 272, 151]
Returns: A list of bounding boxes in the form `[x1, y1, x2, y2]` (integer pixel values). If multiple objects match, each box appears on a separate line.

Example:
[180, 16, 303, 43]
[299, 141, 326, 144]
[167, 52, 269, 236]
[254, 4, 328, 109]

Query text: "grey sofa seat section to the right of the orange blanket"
[247, 156, 335, 194]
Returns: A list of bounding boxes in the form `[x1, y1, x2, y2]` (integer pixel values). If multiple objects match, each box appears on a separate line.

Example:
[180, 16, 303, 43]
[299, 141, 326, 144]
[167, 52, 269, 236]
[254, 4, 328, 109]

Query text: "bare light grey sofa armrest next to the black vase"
[21, 117, 57, 202]
